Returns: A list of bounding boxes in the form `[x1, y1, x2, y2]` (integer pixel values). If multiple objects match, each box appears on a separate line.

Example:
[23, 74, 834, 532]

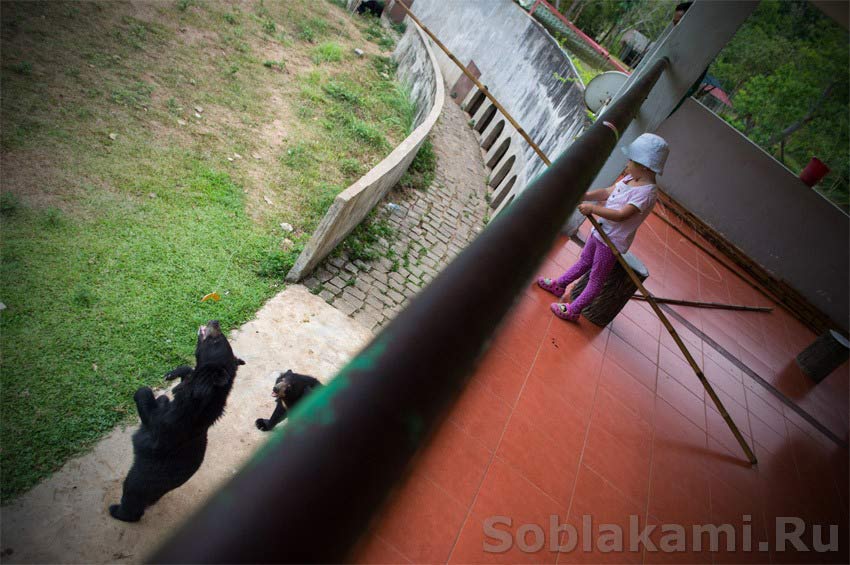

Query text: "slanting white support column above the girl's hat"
[588, 0, 758, 189]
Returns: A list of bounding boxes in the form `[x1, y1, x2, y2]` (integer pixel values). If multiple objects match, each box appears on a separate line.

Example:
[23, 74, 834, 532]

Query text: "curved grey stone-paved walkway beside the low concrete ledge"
[304, 89, 488, 331]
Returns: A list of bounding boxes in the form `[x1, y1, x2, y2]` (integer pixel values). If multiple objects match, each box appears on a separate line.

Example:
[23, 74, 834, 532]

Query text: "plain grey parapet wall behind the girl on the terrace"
[657, 99, 850, 330]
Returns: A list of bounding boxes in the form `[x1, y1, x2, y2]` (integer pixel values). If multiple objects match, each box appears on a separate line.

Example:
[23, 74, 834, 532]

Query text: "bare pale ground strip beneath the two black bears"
[2, 285, 372, 563]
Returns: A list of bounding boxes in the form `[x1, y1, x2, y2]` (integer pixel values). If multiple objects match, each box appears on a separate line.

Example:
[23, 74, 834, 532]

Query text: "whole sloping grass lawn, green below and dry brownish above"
[0, 0, 414, 501]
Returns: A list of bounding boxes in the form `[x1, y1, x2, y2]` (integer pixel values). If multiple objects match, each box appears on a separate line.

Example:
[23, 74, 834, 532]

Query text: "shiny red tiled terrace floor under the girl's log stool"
[356, 216, 850, 563]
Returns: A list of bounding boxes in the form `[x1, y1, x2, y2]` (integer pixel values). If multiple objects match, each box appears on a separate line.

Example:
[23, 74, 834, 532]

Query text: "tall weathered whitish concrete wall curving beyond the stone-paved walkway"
[412, 0, 585, 183]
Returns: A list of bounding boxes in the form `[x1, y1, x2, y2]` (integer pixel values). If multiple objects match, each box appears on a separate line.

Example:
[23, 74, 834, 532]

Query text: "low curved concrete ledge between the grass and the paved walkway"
[286, 21, 445, 282]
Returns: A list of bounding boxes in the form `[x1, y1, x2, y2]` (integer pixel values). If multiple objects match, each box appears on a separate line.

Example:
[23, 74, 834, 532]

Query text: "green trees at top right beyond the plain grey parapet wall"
[709, 0, 850, 210]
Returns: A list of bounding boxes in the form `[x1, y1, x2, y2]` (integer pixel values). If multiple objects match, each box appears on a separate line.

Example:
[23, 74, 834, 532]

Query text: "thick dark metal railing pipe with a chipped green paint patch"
[151, 60, 666, 563]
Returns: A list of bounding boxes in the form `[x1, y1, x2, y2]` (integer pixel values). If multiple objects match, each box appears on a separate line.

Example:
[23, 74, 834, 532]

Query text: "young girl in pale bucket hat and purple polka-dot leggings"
[537, 133, 669, 322]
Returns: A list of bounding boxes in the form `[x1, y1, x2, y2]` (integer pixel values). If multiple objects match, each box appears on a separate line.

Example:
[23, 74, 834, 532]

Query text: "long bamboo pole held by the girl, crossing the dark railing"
[396, 0, 758, 465]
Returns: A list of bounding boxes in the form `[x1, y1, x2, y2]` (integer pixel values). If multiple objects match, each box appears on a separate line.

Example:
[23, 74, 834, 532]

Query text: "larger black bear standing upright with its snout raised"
[109, 320, 245, 522]
